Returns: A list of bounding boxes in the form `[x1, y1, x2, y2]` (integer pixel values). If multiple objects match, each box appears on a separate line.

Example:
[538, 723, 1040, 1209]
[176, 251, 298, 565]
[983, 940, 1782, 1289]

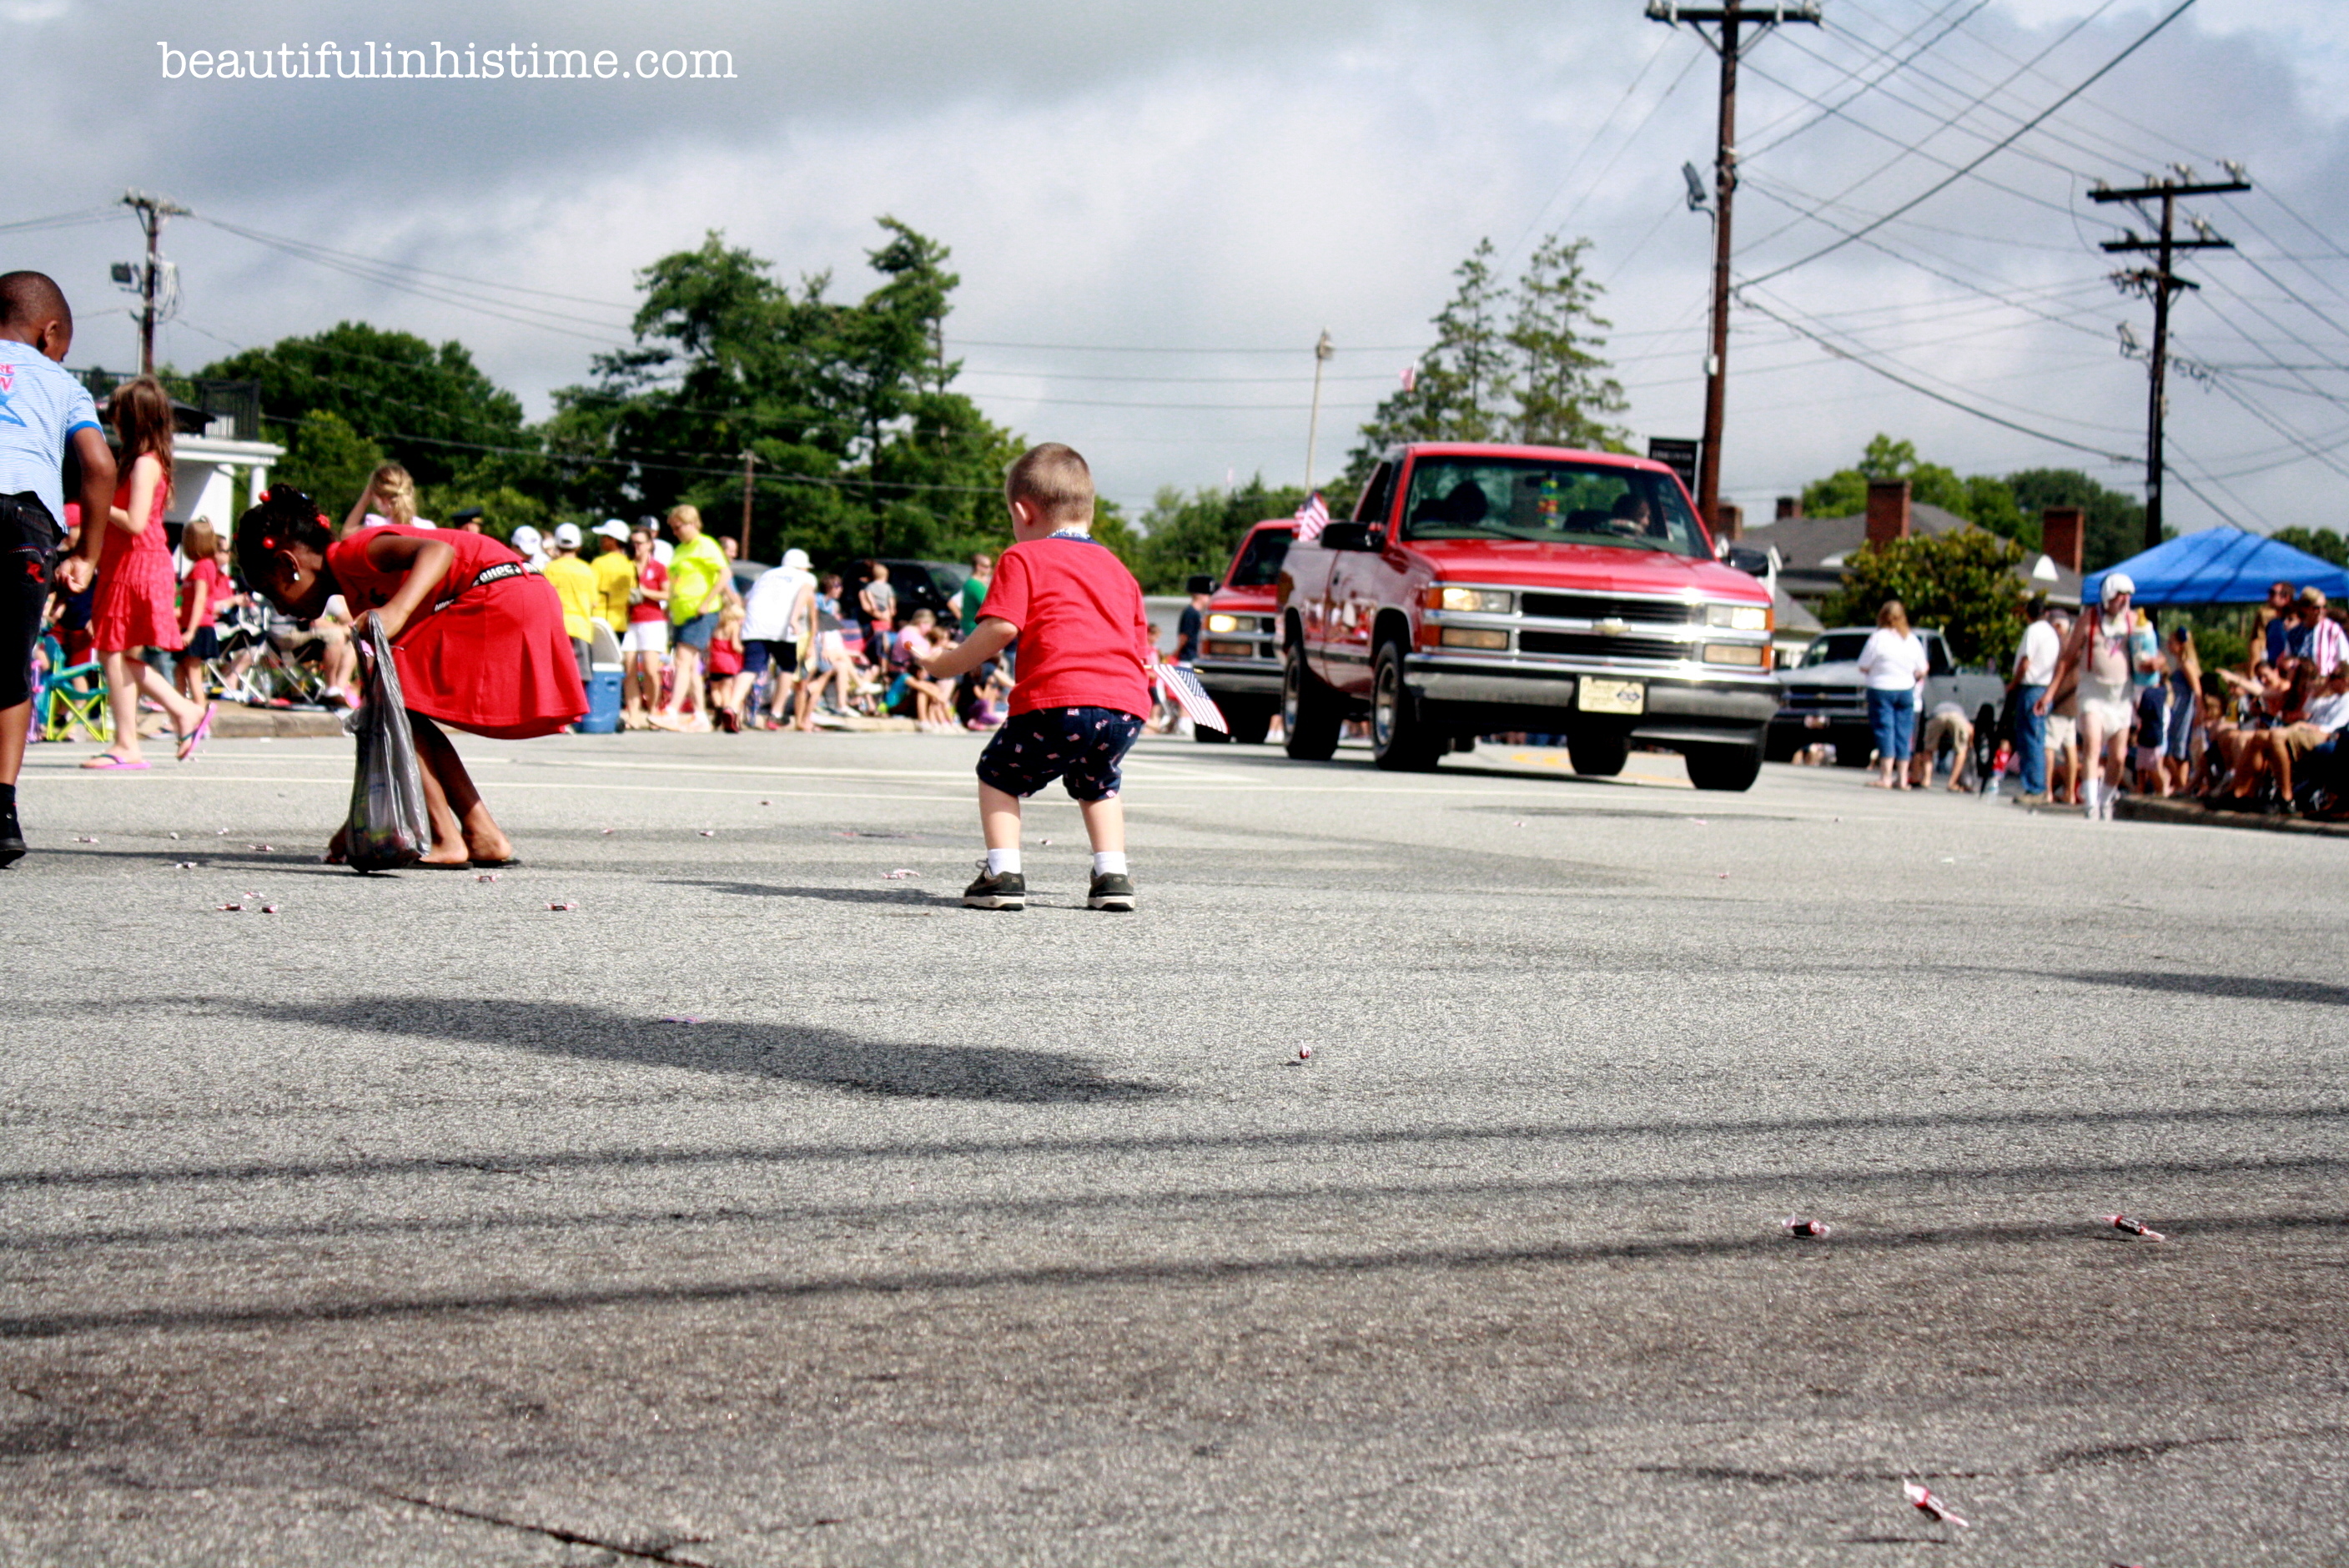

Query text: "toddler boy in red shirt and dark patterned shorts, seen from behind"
[921, 441, 1154, 911]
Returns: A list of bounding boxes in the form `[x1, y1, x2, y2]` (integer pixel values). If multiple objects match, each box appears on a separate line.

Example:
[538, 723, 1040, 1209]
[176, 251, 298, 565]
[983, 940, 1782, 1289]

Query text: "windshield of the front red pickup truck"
[1402, 455, 1710, 556]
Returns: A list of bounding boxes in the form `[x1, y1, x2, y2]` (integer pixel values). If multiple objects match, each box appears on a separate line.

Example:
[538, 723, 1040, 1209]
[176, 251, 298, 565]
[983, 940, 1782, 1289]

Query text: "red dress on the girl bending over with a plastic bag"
[326, 524, 587, 740]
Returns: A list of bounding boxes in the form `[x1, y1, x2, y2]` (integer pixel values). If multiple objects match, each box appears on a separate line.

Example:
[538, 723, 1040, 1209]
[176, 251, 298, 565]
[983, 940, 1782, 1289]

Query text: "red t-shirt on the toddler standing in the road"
[979, 535, 1151, 718]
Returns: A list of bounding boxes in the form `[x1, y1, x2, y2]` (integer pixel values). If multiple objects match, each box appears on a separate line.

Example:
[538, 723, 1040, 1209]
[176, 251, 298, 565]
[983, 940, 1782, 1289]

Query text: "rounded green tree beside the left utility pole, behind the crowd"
[202, 322, 536, 485]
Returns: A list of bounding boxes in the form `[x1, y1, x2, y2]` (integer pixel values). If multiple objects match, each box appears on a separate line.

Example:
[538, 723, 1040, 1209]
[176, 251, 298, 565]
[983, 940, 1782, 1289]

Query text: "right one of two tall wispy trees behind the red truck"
[1503, 234, 1630, 450]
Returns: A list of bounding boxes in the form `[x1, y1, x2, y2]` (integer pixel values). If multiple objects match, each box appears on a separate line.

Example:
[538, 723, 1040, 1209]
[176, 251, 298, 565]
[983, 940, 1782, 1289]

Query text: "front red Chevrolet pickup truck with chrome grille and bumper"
[1275, 444, 1781, 789]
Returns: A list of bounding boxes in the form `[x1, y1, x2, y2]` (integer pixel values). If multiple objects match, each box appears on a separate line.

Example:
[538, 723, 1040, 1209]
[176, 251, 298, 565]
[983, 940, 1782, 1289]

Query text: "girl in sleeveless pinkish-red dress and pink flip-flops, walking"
[83, 375, 211, 770]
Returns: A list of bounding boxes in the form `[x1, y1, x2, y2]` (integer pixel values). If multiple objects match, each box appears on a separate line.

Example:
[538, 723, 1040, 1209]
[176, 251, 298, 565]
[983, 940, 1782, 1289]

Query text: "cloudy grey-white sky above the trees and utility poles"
[0, 0, 2349, 528]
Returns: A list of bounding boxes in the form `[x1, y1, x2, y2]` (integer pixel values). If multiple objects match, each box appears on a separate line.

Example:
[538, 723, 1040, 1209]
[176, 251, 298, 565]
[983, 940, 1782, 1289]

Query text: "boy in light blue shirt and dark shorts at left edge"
[0, 272, 115, 867]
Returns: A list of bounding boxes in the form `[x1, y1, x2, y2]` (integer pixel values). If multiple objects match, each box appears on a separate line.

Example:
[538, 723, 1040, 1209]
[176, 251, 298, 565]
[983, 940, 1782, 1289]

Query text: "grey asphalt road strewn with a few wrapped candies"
[0, 735, 2349, 1568]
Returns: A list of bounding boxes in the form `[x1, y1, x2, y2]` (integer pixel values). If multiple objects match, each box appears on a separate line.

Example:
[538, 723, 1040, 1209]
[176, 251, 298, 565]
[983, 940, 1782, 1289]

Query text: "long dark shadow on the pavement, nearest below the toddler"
[237, 995, 1169, 1106]
